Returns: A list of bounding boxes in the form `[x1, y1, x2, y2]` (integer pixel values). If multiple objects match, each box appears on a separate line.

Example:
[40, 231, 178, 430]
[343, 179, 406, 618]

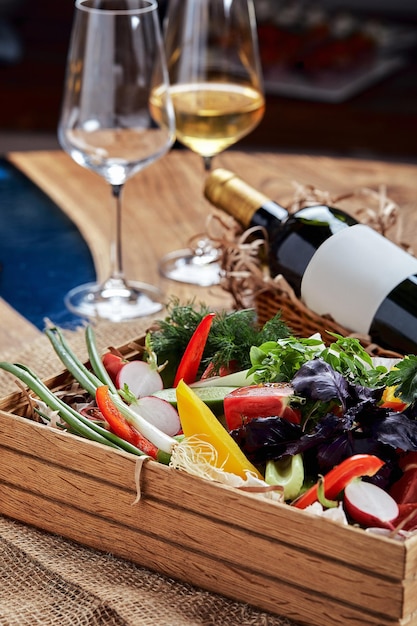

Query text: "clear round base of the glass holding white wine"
[159, 249, 222, 287]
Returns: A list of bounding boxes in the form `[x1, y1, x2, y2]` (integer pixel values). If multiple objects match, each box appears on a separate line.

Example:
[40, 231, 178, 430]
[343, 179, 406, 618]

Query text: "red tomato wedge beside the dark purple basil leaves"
[223, 383, 301, 430]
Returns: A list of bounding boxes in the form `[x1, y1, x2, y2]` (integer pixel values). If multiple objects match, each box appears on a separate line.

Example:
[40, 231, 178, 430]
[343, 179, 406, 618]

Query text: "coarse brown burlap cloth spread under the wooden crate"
[0, 319, 293, 626]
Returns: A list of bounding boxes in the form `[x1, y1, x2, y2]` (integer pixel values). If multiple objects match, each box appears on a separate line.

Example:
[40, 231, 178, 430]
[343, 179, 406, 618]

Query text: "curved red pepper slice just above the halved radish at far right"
[293, 454, 384, 509]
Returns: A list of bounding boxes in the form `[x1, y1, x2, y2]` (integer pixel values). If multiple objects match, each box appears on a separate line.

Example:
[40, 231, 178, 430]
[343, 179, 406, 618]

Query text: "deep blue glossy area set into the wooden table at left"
[0, 159, 96, 330]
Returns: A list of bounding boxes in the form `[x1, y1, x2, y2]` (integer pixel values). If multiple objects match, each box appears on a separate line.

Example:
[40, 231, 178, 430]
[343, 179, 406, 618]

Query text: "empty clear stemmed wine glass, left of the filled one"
[58, 0, 175, 322]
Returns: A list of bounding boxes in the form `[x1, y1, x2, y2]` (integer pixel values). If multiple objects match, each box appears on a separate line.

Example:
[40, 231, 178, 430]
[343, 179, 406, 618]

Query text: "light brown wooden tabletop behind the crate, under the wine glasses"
[0, 145, 417, 351]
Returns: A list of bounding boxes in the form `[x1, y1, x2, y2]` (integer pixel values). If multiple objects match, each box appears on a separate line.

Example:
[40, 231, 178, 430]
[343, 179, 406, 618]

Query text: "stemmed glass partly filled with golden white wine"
[152, 0, 265, 286]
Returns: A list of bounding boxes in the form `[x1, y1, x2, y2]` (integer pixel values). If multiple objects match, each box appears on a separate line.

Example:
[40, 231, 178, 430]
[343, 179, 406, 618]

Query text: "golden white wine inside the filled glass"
[150, 82, 265, 157]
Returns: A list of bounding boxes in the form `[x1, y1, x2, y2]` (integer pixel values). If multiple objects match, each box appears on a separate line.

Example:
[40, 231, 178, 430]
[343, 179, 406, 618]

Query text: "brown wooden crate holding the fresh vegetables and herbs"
[0, 342, 417, 626]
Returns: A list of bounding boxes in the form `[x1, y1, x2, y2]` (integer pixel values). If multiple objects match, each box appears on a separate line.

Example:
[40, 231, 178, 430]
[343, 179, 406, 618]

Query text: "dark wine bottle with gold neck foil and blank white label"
[204, 169, 417, 354]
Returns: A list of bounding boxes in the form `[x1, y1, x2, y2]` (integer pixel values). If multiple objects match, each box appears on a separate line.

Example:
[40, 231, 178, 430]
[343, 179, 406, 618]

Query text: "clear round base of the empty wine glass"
[65, 282, 163, 322]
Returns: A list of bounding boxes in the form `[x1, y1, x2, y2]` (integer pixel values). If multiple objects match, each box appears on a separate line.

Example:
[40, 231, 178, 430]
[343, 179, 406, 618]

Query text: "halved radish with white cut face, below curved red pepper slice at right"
[344, 480, 399, 530]
